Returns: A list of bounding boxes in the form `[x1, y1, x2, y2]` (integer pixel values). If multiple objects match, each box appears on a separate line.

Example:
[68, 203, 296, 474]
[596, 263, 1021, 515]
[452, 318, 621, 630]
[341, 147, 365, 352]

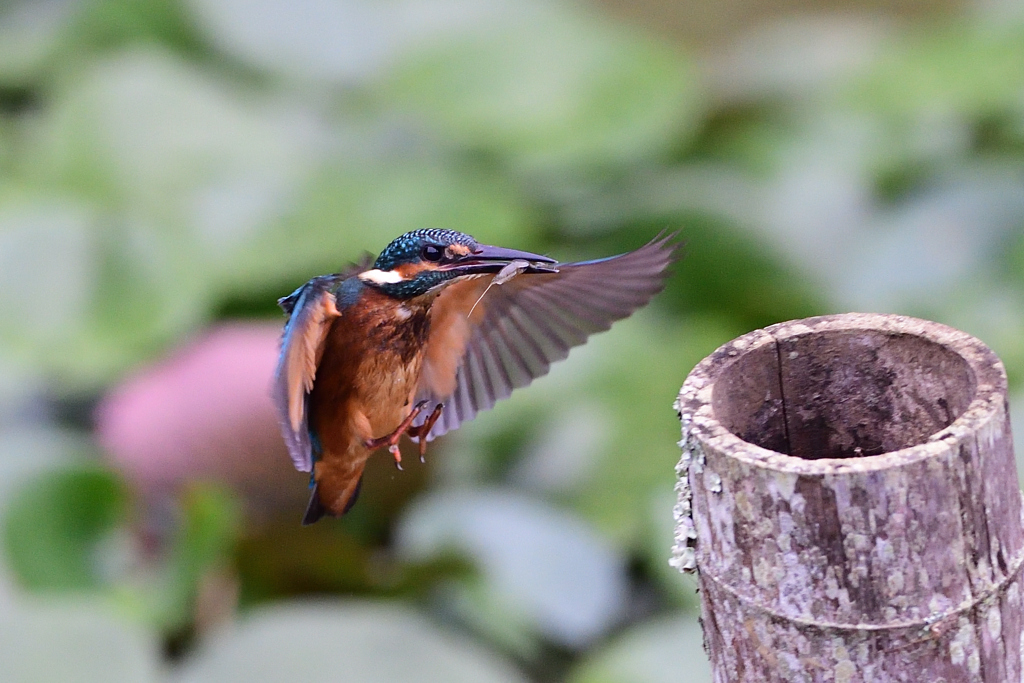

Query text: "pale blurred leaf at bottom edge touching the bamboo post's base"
[566, 614, 712, 683]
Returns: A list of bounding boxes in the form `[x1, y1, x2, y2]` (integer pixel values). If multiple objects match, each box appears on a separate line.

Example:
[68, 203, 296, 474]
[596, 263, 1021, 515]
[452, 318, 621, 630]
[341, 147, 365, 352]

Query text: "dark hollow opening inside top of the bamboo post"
[712, 330, 977, 460]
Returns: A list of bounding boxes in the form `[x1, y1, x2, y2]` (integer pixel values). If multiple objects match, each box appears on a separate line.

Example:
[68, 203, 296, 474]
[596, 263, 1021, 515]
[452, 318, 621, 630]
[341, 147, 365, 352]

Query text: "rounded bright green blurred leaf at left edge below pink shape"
[4, 469, 126, 590]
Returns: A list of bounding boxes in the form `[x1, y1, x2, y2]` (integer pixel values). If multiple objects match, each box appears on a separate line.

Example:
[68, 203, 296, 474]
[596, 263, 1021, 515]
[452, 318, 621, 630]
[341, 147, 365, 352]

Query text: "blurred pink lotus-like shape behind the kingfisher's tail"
[96, 323, 307, 515]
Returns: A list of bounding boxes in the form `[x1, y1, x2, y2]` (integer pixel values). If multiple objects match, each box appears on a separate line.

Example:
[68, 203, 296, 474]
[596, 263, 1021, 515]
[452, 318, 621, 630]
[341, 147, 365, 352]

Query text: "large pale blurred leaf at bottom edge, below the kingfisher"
[170, 602, 525, 683]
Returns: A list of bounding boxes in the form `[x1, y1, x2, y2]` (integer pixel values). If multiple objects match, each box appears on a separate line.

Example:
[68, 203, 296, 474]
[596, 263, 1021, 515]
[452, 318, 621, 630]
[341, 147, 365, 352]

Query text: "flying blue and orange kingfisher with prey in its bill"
[273, 229, 678, 524]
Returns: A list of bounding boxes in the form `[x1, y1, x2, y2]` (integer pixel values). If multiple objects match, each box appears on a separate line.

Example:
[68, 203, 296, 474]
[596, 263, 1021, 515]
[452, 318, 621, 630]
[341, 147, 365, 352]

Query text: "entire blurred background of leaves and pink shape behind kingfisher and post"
[0, 0, 1024, 683]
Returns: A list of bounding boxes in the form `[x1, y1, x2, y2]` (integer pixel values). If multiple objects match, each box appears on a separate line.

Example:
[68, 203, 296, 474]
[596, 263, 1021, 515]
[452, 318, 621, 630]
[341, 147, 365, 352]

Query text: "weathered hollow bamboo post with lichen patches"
[673, 313, 1024, 683]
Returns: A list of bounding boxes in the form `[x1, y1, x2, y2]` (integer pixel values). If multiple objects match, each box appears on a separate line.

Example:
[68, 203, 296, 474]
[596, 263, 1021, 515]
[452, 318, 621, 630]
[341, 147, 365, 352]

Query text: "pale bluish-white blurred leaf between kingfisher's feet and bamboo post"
[397, 489, 627, 647]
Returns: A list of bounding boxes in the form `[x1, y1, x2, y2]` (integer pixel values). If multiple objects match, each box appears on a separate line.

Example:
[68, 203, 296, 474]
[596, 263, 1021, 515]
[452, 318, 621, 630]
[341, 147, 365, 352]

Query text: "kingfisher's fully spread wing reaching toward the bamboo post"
[418, 234, 679, 438]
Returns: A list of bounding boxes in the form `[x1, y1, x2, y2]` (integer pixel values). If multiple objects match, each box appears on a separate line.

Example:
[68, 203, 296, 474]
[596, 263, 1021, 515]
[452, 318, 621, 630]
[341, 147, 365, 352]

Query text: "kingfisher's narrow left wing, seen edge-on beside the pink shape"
[272, 275, 342, 472]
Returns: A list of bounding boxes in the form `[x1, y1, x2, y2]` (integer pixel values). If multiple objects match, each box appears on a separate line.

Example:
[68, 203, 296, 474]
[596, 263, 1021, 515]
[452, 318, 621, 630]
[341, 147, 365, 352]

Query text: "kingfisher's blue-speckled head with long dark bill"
[358, 229, 556, 299]
